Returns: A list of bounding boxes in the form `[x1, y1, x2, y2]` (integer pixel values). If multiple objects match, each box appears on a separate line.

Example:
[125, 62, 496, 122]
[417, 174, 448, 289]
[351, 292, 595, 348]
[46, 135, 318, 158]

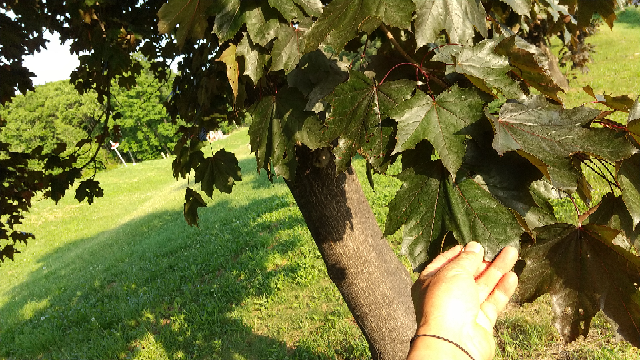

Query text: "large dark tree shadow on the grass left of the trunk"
[0, 158, 338, 360]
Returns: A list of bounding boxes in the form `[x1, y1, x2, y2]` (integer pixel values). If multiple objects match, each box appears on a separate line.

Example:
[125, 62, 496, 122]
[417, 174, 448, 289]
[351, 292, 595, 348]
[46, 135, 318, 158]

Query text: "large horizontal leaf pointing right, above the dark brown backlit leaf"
[487, 96, 637, 190]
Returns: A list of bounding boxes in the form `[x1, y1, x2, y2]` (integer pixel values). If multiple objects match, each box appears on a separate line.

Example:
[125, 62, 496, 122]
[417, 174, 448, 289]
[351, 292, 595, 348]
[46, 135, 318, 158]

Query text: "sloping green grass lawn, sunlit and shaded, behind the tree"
[0, 10, 640, 360]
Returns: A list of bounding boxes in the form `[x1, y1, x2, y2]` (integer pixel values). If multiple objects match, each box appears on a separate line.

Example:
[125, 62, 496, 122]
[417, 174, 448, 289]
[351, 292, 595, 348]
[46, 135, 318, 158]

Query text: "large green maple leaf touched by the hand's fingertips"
[385, 144, 523, 270]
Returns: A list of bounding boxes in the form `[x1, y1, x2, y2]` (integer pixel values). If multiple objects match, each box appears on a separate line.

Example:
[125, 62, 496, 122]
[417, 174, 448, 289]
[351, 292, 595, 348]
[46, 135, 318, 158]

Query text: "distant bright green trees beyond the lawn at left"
[0, 58, 180, 165]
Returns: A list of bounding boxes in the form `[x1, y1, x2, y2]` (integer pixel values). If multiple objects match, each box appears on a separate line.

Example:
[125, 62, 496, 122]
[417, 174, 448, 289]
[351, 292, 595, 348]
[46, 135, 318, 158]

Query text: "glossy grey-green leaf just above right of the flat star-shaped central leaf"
[433, 40, 524, 99]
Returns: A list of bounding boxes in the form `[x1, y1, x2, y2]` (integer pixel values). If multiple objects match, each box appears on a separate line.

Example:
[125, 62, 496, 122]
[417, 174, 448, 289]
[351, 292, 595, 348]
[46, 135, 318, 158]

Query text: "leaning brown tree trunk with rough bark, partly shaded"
[287, 146, 416, 360]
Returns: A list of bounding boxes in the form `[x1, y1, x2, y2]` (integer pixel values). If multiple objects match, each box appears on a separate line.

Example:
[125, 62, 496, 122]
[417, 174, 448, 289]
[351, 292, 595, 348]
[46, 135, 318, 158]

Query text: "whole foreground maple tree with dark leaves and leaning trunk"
[0, 0, 640, 359]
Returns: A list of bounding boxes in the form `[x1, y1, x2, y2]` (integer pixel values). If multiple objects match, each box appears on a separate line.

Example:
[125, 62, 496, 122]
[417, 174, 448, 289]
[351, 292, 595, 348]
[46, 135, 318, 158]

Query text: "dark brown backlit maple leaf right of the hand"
[514, 224, 640, 347]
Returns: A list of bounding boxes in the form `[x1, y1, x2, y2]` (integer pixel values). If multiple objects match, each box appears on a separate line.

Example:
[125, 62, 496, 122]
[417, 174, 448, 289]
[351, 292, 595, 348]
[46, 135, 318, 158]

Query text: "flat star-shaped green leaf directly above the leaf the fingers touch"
[390, 85, 484, 174]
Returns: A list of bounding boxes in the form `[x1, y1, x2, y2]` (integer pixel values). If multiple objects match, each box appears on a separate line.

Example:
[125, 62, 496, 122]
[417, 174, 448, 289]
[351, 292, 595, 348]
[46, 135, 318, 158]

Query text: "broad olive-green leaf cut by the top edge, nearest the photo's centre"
[304, 0, 416, 53]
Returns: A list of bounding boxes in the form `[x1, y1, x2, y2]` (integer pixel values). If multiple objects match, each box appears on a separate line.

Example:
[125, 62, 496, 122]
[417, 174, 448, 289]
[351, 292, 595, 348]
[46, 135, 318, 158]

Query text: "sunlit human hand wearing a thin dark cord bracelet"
[407, 242, 518, 360]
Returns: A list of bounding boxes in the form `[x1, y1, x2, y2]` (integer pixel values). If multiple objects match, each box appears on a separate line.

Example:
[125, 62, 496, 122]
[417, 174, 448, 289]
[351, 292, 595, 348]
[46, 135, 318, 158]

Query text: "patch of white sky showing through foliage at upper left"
[24, 33, 80, 85]
